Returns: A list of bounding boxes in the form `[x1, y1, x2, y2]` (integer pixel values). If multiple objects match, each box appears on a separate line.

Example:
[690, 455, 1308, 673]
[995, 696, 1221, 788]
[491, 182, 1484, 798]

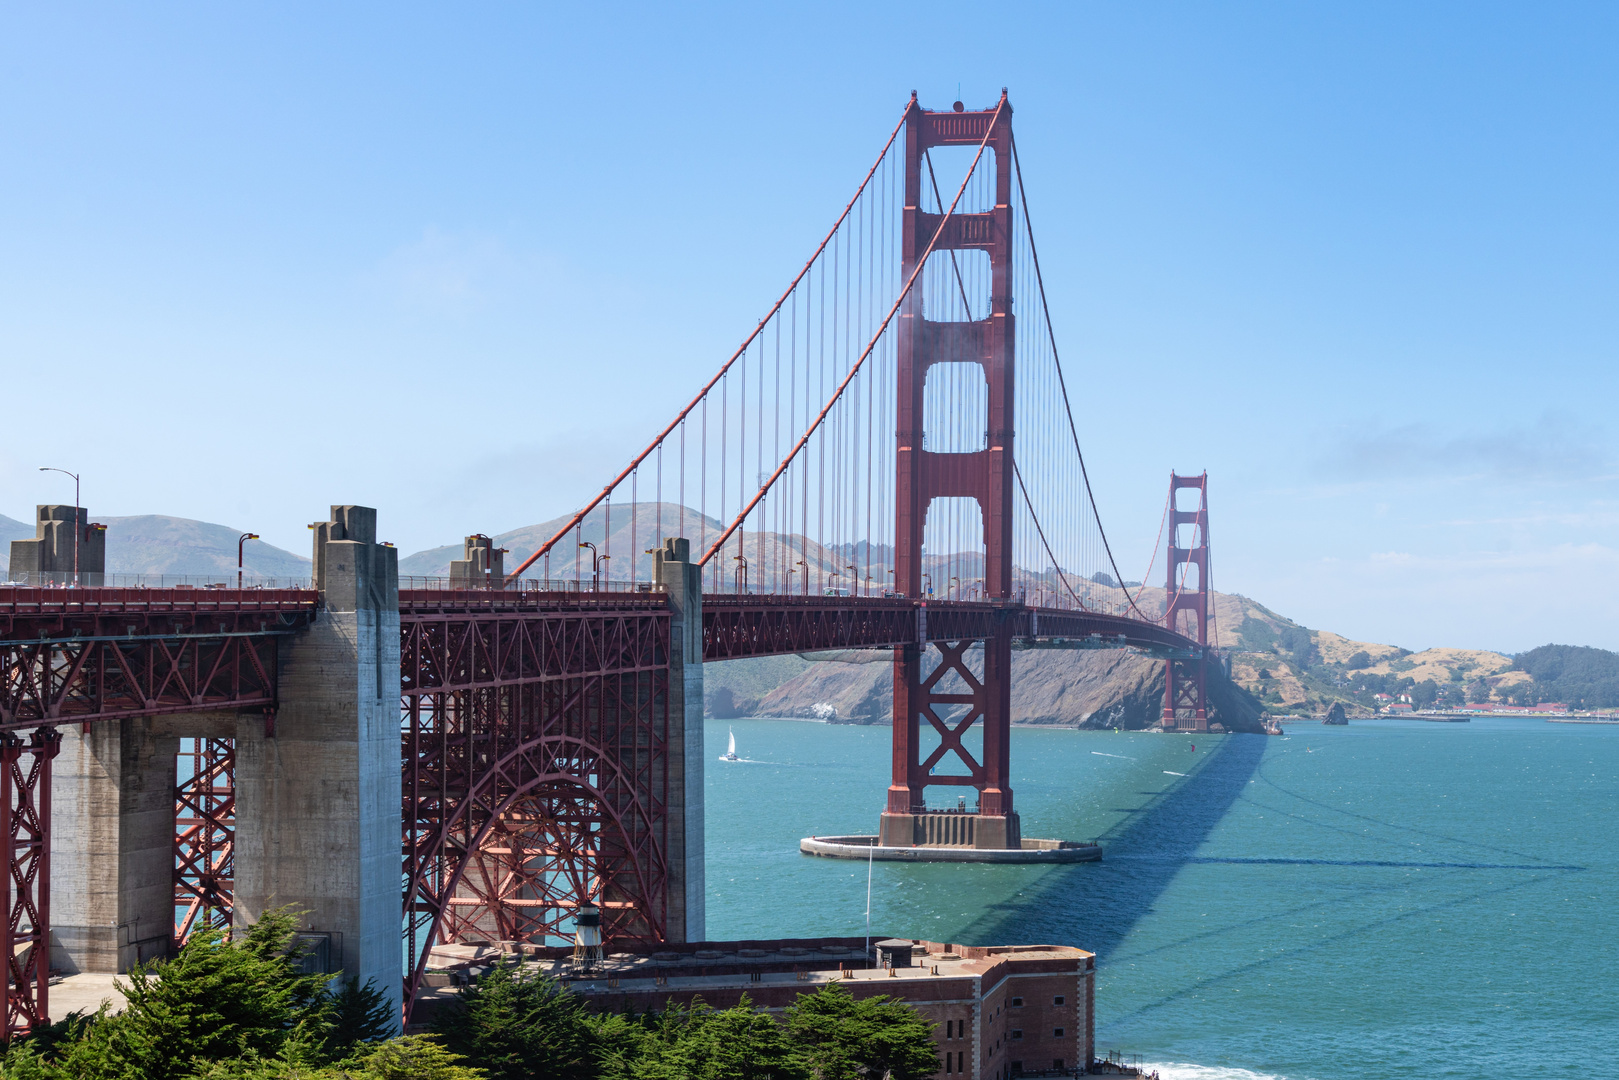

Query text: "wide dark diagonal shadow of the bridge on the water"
[962, 735, 1268, 960]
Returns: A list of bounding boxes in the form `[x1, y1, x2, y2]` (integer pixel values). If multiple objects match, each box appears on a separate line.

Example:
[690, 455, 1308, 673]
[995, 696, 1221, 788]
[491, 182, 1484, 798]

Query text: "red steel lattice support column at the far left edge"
[0, 727, 62, 1040]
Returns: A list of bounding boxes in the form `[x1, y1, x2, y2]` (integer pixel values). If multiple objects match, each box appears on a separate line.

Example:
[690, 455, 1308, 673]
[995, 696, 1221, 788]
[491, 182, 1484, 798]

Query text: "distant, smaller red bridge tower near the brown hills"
[1164, 471, 1209, 732]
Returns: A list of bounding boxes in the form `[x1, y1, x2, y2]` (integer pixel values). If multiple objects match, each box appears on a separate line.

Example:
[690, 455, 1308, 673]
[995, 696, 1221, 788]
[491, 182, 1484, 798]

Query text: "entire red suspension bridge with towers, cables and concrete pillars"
[0, 92, 1211, 1033]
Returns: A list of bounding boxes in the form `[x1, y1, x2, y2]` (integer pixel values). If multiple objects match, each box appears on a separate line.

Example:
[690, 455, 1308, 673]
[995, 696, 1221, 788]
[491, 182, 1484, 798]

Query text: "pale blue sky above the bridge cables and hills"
[0, 3, 1619, 649]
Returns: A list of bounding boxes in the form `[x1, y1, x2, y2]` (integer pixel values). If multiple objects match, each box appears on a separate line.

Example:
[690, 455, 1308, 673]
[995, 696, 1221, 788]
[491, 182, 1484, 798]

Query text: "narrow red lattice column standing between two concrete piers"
[175, 738, 236, 946]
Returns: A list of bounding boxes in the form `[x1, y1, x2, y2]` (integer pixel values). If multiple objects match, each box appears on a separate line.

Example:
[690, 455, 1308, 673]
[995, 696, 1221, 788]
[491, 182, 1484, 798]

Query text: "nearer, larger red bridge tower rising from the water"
[879, 91, 1022, 848]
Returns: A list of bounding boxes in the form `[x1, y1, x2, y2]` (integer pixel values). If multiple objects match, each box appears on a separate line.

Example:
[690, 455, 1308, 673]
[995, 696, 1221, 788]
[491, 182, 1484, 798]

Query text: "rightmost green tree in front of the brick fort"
[787, 983, 939, 1080]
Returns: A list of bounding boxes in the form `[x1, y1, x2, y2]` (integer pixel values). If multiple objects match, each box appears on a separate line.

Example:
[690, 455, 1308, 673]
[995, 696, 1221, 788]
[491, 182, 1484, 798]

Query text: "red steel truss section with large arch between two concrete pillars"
[400, 594, 670, 1001]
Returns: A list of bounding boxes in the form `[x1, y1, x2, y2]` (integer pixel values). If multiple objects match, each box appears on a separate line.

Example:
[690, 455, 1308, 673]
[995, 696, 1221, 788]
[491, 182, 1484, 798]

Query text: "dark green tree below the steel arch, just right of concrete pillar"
[434, 963, 596, 1080]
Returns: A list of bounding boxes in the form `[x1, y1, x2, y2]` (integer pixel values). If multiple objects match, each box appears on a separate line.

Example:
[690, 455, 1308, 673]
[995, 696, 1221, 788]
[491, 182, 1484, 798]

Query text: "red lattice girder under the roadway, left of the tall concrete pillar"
[0, 631, 286, 730]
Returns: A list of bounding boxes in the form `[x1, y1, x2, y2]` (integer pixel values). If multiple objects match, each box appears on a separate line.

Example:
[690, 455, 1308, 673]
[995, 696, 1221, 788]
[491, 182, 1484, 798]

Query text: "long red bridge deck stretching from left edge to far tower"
[0, 588, 1198, 730]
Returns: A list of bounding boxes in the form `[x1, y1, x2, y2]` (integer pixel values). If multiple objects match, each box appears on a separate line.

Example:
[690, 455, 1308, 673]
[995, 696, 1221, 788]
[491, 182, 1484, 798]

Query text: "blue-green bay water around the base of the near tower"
[706, 719, 1619, 1080]
